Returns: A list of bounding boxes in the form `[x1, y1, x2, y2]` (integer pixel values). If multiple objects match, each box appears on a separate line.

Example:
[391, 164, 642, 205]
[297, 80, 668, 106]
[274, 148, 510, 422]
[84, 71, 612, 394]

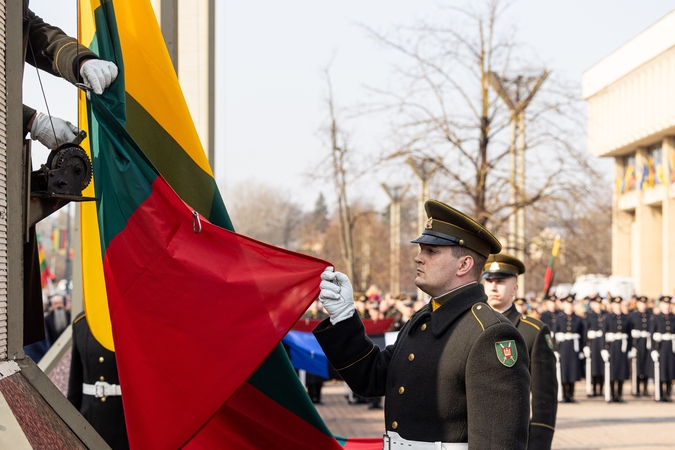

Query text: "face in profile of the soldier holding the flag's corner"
[415, 244, 473, 297]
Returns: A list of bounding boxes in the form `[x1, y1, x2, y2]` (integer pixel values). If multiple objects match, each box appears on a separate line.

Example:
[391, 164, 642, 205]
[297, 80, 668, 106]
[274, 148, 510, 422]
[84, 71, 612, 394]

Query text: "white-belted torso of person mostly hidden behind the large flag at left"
[68, 313, 129, 450]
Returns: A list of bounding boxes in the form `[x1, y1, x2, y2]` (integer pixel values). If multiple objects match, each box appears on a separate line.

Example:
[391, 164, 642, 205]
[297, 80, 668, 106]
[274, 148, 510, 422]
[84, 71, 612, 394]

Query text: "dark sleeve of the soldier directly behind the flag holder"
[528, 325, 558, 450]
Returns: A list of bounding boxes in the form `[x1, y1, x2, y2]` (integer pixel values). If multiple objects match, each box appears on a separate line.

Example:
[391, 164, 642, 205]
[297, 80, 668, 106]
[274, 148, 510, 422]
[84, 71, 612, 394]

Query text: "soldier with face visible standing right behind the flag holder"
[483, 253, 558, 450]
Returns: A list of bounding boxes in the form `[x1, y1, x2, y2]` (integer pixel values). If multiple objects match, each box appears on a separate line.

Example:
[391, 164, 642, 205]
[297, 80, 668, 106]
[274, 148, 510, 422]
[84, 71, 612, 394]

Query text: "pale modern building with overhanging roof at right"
[582, 11, 675, 297]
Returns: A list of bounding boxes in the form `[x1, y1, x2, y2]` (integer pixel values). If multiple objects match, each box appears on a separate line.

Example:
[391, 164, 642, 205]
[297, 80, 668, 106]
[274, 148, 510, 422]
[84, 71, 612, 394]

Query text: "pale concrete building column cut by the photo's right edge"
[661, 136, 675, 295]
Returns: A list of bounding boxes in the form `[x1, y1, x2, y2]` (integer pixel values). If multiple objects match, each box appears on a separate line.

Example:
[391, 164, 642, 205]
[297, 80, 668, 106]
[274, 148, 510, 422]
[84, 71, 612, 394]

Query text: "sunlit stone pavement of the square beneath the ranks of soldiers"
[317, 381, 675, 450]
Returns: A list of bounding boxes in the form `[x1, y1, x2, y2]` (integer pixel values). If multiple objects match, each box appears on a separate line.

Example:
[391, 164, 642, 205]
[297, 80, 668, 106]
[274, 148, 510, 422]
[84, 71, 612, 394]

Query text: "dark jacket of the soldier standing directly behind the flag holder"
[502, 306, 558, 450]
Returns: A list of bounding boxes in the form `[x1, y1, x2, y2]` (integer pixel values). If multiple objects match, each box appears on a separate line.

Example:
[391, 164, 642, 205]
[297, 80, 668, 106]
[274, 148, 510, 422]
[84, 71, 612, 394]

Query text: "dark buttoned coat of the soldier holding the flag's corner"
[314, 284, 530, 450]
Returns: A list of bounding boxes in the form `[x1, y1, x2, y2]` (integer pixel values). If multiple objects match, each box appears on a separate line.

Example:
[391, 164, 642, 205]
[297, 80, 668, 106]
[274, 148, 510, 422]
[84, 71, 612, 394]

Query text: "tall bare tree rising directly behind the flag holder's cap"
[366, 0, 602, 232]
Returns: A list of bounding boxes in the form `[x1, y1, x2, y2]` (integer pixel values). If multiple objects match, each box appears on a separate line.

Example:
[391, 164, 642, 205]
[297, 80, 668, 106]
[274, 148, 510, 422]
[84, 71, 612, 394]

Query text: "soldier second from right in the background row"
[629, 296, 654, 397]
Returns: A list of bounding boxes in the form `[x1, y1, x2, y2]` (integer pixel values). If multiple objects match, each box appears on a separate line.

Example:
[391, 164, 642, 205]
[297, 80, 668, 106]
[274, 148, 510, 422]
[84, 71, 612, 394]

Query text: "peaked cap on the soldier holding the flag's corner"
[410, 200, 502, 258]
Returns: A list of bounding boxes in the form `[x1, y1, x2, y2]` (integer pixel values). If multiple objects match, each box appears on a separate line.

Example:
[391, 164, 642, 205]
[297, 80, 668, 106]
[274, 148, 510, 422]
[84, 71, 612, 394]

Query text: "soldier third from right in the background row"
[602, 297, 633, 403]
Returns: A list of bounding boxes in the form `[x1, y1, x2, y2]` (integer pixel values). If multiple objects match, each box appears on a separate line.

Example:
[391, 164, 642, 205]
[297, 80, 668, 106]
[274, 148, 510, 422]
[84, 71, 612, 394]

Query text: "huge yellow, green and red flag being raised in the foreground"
[79, 0, 370, 449]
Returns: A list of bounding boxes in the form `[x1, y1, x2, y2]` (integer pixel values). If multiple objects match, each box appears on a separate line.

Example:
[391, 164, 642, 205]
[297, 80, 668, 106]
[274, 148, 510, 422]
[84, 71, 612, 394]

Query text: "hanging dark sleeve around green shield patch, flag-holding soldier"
[466, 323, 530, 450]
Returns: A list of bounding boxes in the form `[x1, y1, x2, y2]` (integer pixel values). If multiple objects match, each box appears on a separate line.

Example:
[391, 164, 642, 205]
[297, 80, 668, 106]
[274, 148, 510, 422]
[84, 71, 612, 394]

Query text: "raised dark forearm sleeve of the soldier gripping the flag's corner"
[313, 314, 394, 397]
